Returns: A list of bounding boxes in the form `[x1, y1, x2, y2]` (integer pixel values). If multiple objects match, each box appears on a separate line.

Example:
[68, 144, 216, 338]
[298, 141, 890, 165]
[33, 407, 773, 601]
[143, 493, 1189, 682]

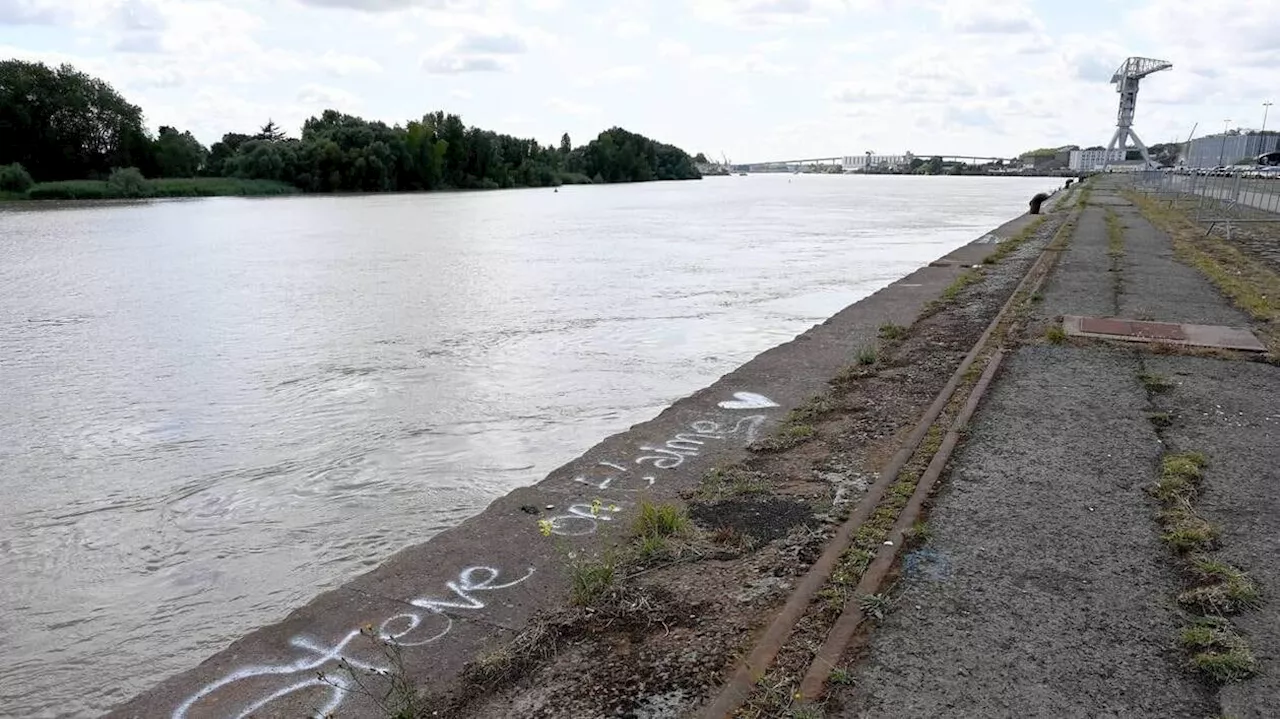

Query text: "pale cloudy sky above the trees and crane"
[0, 0, 1280, 162]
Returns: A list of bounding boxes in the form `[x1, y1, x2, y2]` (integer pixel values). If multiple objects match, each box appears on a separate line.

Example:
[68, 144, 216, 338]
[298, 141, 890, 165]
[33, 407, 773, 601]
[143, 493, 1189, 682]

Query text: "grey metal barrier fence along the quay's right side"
[1133, 170, 1280, 237]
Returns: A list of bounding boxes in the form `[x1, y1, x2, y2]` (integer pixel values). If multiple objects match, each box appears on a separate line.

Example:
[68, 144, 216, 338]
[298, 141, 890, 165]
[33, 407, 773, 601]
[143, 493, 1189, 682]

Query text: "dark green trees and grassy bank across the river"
[0, 60, 701, 200]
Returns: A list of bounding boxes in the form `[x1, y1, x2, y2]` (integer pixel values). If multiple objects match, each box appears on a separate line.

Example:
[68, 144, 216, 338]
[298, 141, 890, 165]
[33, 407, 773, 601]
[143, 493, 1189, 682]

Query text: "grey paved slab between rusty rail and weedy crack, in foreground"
[828, 347, 1213, 719]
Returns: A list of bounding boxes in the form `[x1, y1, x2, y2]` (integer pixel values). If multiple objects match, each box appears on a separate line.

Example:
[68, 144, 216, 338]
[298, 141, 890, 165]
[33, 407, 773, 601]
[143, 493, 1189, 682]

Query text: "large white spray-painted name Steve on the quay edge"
[173, 565, 534, 719]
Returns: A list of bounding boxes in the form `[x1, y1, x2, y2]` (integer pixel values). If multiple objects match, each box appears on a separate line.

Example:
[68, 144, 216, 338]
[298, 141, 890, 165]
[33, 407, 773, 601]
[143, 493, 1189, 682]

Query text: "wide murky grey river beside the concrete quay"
[0, 175, 1057, 716]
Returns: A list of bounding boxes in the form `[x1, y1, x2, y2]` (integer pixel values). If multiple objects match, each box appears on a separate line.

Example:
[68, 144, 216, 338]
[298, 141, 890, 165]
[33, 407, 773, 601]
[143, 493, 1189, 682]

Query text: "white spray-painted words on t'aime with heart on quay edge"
[540, 391, 778, 536]
